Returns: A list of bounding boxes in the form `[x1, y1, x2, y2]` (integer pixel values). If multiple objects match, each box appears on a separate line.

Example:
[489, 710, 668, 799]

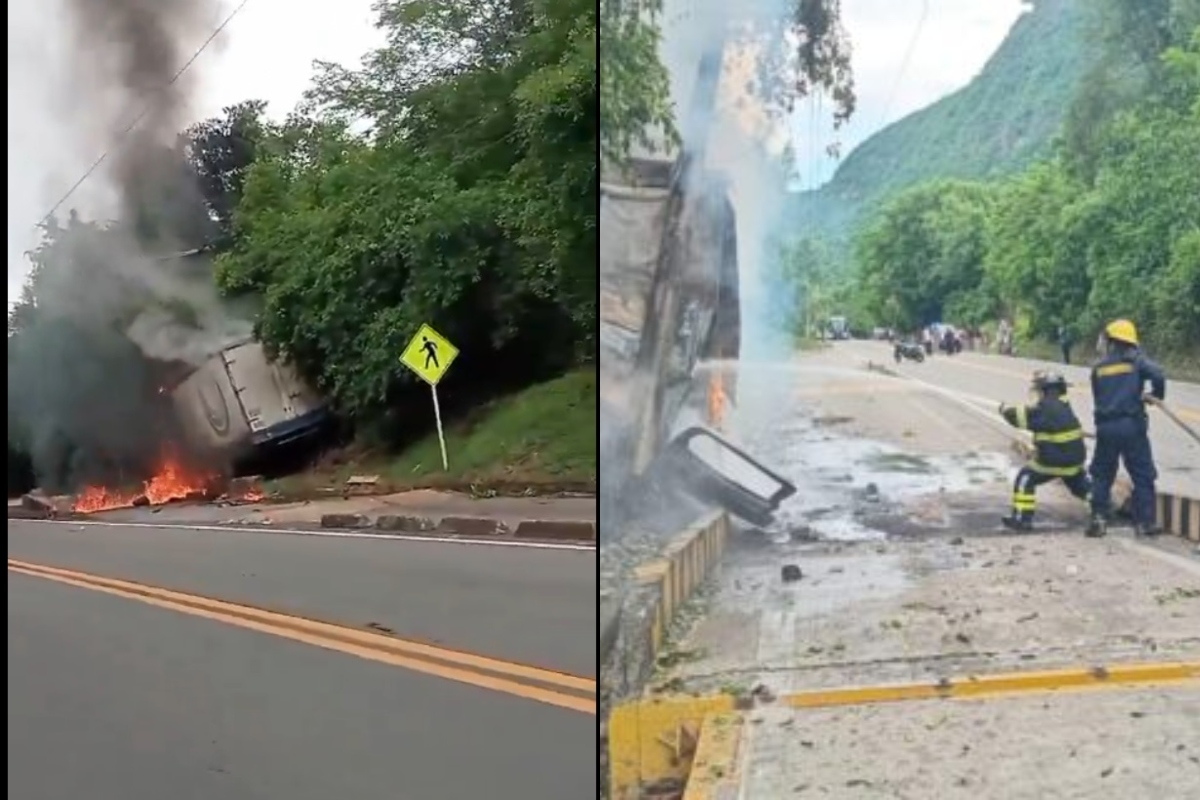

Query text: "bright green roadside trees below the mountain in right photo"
[858, 21, 1200, 356]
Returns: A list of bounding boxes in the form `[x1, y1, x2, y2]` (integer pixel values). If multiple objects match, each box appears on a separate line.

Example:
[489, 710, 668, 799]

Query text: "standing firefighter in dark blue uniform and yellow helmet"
[1087, 319, 1166, 536]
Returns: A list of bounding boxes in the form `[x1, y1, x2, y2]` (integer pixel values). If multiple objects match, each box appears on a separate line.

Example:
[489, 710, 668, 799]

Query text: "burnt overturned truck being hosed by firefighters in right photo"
[600, 157, 794, 536]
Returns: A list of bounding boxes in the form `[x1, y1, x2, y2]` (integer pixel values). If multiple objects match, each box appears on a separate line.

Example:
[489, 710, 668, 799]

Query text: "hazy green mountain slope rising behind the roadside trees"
[788, 0, 1088, 247]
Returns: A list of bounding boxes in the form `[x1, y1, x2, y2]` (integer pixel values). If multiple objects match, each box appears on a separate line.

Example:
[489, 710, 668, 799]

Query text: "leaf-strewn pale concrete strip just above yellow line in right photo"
[654, 534, 1200, 694]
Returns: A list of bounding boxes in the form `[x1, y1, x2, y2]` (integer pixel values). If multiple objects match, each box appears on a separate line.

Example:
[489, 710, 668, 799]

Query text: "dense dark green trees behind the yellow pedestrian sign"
[217, 0, 599, 438]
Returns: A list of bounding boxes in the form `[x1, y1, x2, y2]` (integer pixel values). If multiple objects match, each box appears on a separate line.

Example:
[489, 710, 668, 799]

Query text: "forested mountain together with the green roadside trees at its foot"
[775, 0, 1200, 365]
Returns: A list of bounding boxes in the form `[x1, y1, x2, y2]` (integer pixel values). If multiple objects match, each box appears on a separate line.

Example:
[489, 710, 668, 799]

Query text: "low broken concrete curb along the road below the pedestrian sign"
[320, 513, 596, 542]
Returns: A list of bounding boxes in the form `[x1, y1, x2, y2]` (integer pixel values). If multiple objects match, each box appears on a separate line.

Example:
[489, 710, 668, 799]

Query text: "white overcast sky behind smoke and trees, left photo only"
[7, 0, 380, 301]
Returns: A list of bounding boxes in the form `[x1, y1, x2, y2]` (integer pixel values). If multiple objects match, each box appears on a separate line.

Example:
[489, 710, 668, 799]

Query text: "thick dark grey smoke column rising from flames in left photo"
[8, 0, 251, 488]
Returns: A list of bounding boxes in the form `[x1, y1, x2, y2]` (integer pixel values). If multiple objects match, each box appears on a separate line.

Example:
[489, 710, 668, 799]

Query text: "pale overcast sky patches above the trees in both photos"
[7, 0, 1021, 300]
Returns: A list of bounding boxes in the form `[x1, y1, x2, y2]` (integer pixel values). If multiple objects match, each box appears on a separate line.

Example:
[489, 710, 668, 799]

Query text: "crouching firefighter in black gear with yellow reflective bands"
[1000, 372, 1092, 531]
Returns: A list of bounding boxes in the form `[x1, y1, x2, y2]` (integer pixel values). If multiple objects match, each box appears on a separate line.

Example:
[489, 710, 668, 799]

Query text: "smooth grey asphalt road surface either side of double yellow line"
[8, 521, 596, 800]
